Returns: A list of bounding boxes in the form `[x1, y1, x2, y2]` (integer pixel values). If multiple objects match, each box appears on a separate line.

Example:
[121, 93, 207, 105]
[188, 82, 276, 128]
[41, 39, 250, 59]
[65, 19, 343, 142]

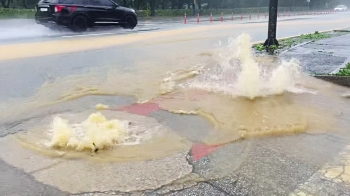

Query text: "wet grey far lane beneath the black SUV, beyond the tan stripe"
[0, 13, 348, 44]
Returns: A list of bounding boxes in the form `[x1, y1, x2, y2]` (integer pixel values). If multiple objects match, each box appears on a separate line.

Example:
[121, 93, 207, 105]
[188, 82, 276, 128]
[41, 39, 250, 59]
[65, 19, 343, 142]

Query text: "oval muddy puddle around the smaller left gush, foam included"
[14, 110, 191, 162]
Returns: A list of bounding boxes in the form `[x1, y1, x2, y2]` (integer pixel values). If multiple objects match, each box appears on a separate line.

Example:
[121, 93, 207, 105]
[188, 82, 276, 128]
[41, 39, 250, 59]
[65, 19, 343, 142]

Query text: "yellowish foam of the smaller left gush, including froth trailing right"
[45, 112, 156, 151]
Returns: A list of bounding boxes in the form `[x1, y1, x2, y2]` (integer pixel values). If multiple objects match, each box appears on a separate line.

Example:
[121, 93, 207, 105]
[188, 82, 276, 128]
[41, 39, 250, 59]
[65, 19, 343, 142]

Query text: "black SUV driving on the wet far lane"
[35, 0, 137, 32]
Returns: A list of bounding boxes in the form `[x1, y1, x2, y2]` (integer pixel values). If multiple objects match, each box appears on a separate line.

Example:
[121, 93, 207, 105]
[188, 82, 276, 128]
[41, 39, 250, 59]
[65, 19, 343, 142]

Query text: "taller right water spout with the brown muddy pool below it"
[156, 34, 334, 145]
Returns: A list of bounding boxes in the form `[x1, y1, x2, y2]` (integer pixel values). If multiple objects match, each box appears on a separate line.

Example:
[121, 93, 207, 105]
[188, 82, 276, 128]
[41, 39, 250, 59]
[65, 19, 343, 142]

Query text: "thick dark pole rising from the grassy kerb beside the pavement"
[264, 0, 279, 51]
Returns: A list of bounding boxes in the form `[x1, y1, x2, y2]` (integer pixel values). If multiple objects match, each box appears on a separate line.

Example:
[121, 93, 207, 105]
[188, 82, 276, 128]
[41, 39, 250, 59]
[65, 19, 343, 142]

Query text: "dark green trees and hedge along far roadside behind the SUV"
[0, 0, 338, 18]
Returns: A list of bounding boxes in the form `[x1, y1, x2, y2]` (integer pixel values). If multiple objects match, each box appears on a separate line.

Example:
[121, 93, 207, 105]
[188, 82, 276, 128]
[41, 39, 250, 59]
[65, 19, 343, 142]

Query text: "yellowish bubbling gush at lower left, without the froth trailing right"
[49, 113, 126, 151]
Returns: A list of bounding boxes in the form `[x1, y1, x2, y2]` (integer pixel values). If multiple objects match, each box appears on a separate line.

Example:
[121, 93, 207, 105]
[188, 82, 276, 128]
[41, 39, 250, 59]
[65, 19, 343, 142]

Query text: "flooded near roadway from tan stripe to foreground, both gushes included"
[0, 13, 350, 196]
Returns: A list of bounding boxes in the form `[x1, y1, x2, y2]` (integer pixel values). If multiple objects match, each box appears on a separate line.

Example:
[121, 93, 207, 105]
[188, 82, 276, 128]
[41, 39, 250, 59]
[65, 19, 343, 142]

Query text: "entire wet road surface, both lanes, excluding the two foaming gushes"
[0, 12, 350, 196]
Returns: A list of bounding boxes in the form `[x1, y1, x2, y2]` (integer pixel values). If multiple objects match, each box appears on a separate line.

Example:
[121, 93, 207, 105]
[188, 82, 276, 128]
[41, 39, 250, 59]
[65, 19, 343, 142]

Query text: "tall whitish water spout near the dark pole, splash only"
[182, 34, 307, 99]
